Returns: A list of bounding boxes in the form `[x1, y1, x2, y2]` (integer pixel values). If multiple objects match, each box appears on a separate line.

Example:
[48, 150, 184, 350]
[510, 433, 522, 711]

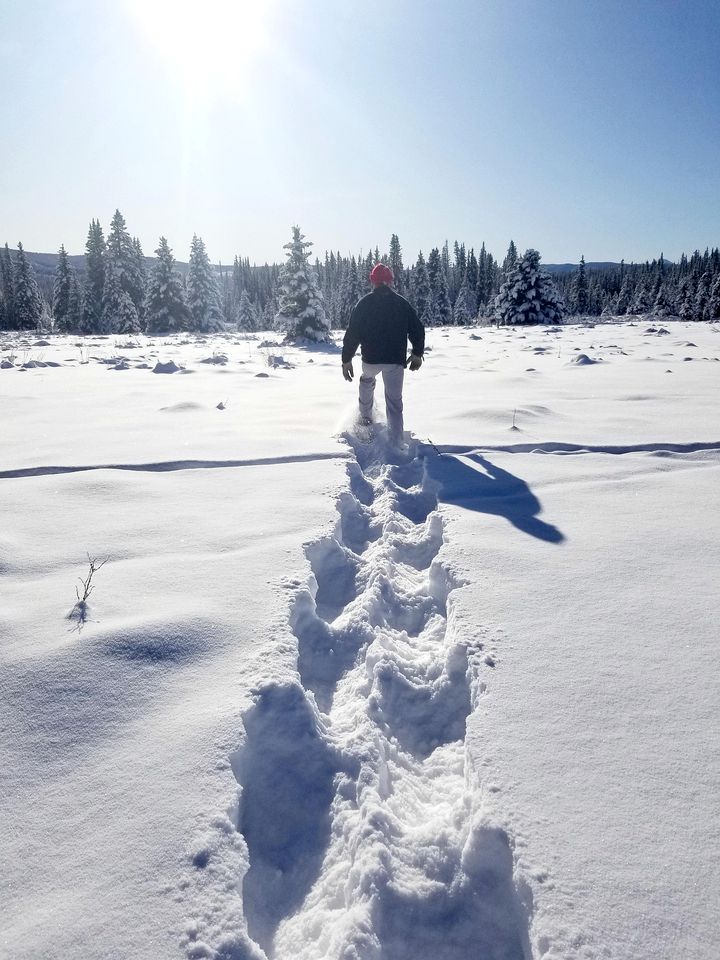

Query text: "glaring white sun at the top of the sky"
[126, 0, 276, 99]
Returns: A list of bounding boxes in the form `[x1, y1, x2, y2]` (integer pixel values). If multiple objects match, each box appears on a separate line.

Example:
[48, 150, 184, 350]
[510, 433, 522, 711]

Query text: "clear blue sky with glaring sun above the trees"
[0, 0, 720, 262]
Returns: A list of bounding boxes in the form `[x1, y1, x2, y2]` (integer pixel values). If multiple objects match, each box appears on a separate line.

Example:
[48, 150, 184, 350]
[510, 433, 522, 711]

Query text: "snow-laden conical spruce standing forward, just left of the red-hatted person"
[275, 226, 330, 341]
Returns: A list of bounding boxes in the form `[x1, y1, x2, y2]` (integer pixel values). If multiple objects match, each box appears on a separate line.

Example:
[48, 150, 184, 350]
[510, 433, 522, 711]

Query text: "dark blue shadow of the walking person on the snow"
[426, 453, 565, 543]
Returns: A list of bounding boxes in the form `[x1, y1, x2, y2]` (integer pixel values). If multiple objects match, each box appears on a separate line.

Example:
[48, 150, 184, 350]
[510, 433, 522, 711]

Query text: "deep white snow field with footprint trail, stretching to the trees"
[0, 318, 720, 960]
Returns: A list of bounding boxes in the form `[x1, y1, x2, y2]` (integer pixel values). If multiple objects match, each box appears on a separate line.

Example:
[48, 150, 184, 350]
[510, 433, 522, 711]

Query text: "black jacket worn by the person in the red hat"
[342, 284, 425, 367]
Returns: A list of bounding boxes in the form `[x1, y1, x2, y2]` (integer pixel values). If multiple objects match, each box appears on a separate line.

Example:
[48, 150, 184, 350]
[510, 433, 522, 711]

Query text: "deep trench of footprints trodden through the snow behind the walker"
[201, 435, 531, 960]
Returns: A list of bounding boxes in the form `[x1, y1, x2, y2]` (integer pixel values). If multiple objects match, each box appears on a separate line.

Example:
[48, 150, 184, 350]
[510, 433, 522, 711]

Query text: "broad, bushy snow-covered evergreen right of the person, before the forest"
[494, 250, 564, 326]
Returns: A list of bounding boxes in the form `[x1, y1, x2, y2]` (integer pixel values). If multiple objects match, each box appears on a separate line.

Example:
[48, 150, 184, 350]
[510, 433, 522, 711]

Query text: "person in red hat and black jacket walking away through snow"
[342, 263, 425, 446]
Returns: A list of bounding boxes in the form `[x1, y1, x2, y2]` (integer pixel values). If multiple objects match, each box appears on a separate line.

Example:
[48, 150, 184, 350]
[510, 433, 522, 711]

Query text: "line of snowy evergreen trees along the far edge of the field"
[0, 210, 720, 334]
